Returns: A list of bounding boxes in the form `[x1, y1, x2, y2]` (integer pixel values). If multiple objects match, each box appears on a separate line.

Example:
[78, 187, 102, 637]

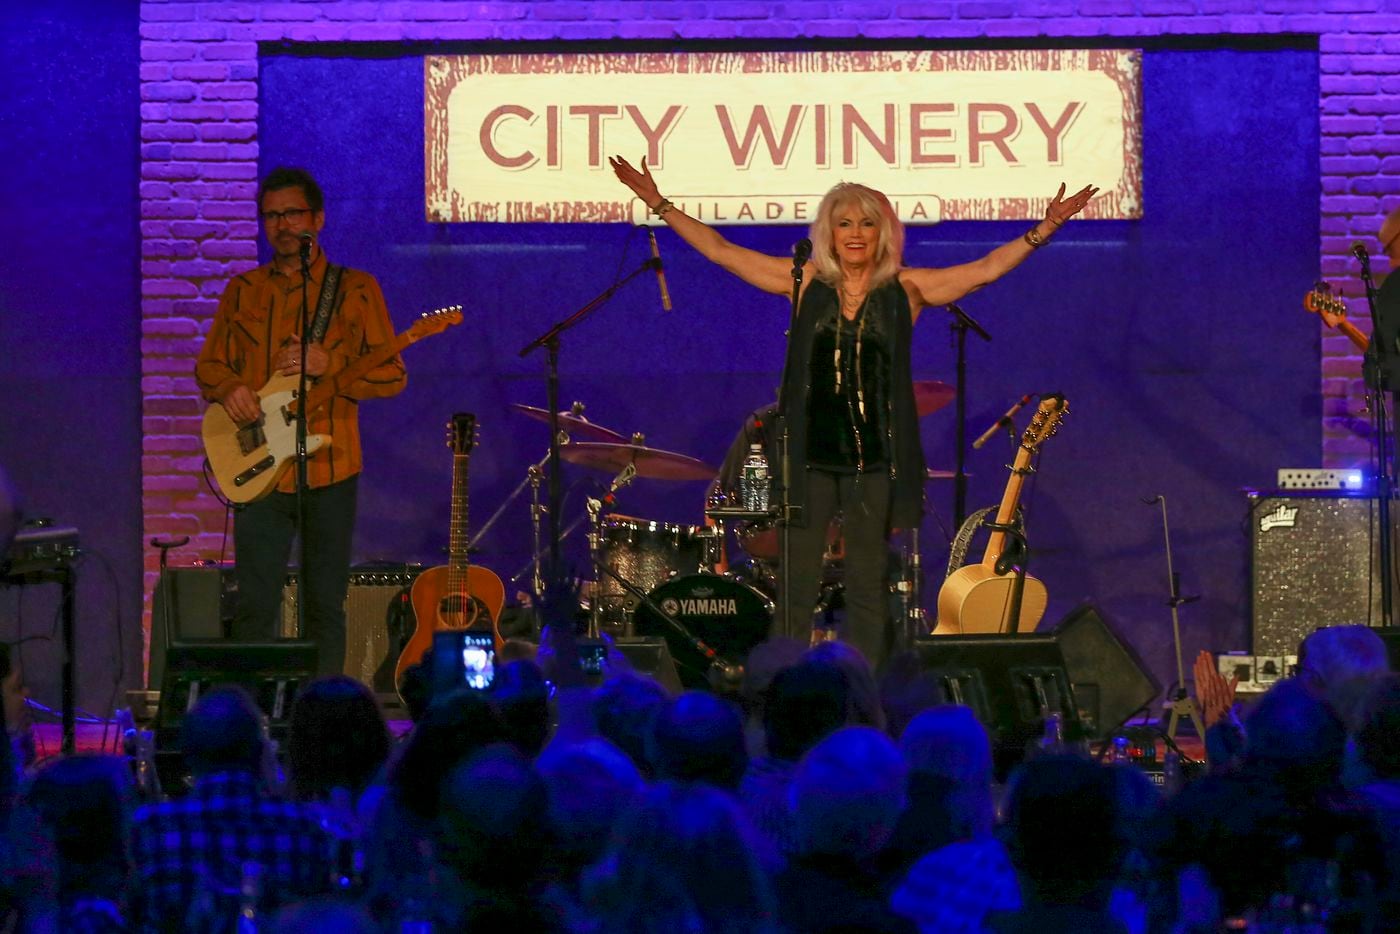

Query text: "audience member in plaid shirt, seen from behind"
[132, 688, 332, 931]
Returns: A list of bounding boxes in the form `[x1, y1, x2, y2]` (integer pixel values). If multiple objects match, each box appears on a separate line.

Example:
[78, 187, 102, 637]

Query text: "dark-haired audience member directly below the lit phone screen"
[361, 688, 505, 921]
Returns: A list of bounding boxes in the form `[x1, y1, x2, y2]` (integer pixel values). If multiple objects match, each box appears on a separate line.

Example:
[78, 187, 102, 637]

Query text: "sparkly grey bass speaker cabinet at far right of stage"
[1246, 492, 1383, 655]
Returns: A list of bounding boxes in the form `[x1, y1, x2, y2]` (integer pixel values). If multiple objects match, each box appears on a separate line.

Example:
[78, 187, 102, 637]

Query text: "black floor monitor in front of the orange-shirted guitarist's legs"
[155, 641, 316, 749]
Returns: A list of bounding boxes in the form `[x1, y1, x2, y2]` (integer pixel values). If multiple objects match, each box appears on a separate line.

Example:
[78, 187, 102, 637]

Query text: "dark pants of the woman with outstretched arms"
[776, 469, 890, 665]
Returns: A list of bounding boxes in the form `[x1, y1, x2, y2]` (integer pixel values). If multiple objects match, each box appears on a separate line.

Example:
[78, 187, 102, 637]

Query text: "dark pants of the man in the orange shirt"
[234, 476, 358, 675]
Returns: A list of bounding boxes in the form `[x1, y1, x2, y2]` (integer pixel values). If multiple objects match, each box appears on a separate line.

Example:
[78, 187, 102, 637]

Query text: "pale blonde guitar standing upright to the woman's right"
[934, 396, 1070, 636]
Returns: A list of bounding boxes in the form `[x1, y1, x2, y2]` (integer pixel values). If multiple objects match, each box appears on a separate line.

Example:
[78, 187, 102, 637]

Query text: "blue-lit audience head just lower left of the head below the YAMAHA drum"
[535, 739, 644, 899]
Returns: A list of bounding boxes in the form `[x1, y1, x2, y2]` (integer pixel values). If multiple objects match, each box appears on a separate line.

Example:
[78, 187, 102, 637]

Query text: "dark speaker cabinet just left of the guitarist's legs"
[146, 564, 238, 690]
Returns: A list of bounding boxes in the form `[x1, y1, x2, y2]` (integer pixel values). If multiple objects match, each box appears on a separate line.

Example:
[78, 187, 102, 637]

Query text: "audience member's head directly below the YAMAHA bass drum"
[647, 690, 749, 793]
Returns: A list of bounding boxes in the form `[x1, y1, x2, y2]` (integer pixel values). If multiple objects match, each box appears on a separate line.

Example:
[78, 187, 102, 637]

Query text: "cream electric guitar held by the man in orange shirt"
[200, 305, 462, 503]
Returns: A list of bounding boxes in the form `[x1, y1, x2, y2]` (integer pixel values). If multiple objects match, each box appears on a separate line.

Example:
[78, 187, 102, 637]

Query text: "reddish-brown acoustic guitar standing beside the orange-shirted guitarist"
[393, 412, 505, 685]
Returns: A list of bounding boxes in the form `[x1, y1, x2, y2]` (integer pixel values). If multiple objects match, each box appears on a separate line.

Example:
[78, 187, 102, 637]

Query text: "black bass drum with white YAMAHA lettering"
[633, 574, 773, 688]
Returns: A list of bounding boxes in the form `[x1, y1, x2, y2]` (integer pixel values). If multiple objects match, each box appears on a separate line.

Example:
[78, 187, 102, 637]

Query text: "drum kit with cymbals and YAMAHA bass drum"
[484, 379, 953, 686]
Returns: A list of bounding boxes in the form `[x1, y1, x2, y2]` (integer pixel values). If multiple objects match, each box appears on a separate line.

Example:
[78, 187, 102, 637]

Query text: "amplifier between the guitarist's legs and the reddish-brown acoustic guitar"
[280, 564, 423, 693]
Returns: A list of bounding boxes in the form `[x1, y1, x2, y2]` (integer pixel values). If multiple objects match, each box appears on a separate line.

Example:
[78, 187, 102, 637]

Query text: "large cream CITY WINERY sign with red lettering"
[424, 49, 1142, 224]
